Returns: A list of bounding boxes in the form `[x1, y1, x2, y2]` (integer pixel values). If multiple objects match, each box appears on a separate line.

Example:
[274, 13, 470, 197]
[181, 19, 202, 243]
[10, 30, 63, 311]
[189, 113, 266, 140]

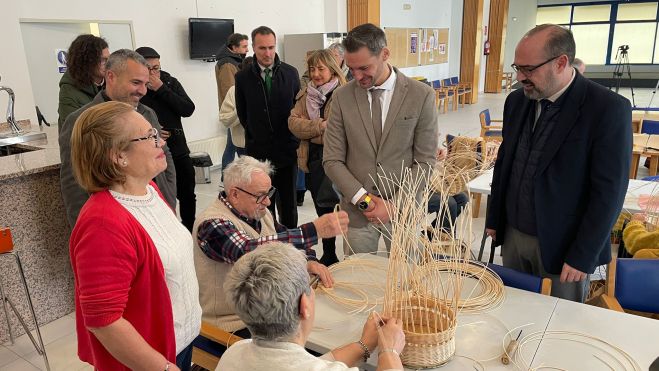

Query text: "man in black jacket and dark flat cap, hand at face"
[135, 46, 197, 231]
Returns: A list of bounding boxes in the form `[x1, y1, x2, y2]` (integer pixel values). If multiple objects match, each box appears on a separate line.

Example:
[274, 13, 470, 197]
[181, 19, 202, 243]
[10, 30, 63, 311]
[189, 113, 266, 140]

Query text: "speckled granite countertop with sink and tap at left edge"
[0, 120, 61, 180]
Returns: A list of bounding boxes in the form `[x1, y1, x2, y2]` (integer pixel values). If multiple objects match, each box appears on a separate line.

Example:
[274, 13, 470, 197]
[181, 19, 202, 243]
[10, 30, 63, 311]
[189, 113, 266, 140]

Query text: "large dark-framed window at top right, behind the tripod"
[536, 0, 659, 65]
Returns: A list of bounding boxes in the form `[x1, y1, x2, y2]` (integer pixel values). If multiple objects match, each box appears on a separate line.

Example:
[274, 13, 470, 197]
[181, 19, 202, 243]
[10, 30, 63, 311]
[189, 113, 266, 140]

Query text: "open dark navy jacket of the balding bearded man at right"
[486, 73, 632, 274]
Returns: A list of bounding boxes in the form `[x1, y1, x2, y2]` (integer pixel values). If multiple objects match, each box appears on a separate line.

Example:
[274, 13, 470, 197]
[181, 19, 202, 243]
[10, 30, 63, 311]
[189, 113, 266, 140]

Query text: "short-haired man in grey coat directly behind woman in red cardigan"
[59, 49, 176, 228]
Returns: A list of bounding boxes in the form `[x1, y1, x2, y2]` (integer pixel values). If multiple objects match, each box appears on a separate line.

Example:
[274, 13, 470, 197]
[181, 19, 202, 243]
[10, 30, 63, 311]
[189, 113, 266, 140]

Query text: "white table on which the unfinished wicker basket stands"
[306, 256, 558, 371]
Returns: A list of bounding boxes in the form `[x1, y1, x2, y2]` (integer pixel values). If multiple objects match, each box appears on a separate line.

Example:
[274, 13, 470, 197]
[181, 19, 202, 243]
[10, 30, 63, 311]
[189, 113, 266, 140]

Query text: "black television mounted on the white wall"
[188, 18, 233, 61]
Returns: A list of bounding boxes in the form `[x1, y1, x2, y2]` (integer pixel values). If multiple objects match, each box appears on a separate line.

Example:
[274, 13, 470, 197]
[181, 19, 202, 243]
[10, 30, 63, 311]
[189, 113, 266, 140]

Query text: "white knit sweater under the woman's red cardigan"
[110, 185, 201, 354]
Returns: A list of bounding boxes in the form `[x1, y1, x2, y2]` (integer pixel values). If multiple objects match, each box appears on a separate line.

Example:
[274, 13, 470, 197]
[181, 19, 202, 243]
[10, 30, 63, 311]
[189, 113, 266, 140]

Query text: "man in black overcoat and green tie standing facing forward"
[236, 26, 300, 228]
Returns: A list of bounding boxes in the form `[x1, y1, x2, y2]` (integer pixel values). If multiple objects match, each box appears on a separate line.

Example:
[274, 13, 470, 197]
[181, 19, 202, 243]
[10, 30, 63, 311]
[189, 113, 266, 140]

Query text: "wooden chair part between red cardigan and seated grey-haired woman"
[192, 321, 242, 371]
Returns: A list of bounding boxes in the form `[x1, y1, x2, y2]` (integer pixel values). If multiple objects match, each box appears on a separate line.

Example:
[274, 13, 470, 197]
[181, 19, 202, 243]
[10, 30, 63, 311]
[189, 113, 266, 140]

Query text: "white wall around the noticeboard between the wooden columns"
[380, 0, 462, 80]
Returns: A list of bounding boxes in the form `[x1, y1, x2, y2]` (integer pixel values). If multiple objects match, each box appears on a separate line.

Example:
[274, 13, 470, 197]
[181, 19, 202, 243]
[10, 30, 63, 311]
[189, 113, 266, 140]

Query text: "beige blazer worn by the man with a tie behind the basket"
[323, 67, 438, 228]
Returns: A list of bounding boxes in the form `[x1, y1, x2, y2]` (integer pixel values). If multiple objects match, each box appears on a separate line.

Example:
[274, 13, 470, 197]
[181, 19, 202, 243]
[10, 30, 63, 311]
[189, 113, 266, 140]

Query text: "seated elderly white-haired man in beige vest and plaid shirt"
[192, 156, 348, 337]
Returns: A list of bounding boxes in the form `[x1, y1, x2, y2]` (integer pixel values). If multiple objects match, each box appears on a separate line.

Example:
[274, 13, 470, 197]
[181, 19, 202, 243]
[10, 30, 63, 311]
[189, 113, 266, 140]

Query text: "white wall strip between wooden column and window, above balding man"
[503, 0, 538, 72]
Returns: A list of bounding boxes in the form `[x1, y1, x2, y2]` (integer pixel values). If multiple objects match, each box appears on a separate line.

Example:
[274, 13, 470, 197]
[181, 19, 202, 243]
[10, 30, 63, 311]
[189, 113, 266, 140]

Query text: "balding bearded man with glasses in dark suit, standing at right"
[486, 25, 632, 301]
